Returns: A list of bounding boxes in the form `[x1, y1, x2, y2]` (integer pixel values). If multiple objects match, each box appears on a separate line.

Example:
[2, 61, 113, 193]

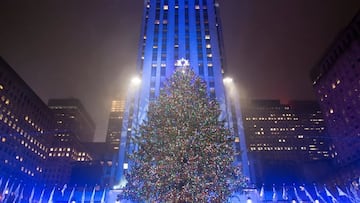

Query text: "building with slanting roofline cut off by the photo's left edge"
[0, 57, 59, 184]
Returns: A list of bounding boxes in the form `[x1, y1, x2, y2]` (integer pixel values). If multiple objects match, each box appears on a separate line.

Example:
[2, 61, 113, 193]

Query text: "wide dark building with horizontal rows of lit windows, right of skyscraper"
[242, 100, 330, 184]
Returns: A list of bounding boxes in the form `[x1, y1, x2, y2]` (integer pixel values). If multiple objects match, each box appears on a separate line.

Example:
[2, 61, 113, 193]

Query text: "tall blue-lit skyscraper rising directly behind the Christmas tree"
[117, 0, 249, 186]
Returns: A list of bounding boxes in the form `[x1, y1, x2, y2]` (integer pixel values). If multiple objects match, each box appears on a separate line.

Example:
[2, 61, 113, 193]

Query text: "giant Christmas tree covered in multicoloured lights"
[121, 67, 244, 202]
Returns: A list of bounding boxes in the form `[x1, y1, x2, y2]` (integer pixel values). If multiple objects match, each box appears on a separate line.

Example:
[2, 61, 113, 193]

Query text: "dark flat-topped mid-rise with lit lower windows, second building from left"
[48, 98, 95, 182]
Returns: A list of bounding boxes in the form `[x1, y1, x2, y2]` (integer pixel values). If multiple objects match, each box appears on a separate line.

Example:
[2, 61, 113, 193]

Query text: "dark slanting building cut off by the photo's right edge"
[311, 13, 360, 181]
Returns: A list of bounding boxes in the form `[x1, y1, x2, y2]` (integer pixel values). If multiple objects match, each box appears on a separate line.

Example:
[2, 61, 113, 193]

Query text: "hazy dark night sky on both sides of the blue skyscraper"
[0, 0, 360, 141]
